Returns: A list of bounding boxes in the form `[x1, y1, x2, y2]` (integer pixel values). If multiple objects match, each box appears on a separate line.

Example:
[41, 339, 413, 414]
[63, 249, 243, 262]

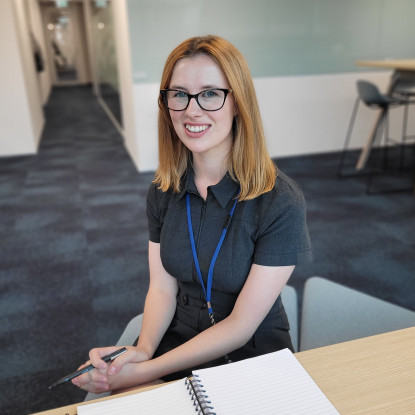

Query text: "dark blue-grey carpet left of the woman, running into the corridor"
[0, 87, 152, 414]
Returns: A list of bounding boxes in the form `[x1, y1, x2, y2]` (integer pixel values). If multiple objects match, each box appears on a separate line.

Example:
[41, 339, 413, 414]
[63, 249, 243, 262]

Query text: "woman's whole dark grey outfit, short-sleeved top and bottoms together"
[147, 169, 311, 379]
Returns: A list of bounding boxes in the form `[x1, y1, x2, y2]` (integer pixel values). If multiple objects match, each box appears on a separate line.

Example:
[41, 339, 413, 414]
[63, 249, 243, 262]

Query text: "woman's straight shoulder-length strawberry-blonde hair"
[154, 35, 277, 200]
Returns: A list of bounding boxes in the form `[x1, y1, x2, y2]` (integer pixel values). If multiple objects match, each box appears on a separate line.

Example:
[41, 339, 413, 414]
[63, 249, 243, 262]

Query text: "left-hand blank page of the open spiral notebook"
[78, 379, 196, 415]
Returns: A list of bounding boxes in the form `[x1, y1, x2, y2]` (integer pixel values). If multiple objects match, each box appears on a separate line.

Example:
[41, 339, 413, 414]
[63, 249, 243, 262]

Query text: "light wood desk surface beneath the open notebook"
[31, 327, 415, 415]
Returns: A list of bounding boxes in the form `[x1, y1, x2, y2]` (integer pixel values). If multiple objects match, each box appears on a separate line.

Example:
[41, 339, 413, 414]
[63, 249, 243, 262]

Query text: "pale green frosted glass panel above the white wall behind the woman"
[128, 0, 415, 83]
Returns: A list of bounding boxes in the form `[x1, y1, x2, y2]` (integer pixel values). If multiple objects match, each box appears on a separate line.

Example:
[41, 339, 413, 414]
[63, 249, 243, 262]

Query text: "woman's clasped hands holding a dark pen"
[72, 346, 150, 393]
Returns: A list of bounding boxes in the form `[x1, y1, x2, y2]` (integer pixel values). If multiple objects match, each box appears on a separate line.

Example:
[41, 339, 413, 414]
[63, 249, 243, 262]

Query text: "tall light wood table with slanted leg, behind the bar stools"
[356, 59, 415, 170]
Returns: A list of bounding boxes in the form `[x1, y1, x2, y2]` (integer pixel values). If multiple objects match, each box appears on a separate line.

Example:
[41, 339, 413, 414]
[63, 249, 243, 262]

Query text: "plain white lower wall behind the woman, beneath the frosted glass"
[134, 72, 415, 171]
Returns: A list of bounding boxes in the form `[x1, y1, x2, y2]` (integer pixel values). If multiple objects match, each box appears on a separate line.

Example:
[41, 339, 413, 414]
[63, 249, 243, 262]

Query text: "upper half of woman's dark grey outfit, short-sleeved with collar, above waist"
[147, 168, 311, 294]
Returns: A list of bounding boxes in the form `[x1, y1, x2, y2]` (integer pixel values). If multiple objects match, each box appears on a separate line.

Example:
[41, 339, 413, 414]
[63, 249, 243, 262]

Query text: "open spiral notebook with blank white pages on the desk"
[78, 349, 339, 415]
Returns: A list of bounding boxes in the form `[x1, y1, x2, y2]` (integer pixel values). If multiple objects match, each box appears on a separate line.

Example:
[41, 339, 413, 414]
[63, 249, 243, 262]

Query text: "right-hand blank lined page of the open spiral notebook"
[193, 349, 339, 415]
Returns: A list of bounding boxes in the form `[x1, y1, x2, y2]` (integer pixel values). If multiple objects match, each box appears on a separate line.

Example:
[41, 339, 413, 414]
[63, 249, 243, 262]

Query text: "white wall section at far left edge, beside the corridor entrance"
[0, 0, 44, 156]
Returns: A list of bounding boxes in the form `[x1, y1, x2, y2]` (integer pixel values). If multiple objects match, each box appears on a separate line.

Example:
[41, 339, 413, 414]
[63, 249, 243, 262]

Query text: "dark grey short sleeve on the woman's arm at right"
[254, 175, 312, 266]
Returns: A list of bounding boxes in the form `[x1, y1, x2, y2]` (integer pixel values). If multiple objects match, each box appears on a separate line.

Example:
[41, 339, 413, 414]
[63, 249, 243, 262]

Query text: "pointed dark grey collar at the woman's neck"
[178, 167, 239, 208]
